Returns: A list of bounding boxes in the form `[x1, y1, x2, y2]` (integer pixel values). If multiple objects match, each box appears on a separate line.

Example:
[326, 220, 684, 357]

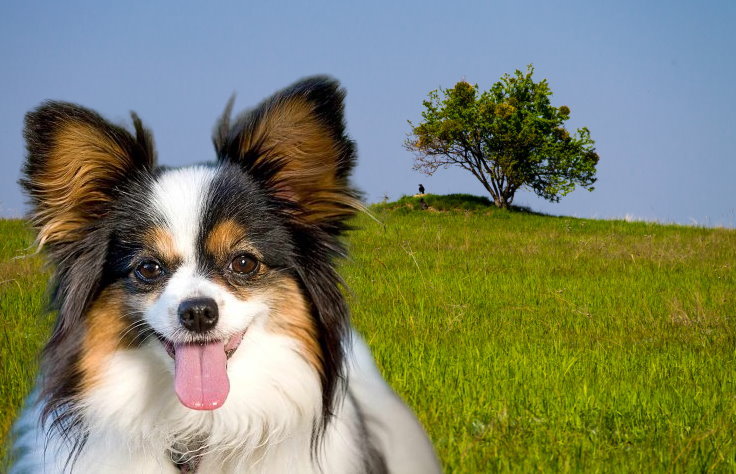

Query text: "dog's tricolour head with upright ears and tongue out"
[21, 77, 359, 436]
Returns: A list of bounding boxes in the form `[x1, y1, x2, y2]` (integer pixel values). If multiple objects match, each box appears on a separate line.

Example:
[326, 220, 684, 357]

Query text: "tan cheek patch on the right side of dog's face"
[266, 277, 323, 374]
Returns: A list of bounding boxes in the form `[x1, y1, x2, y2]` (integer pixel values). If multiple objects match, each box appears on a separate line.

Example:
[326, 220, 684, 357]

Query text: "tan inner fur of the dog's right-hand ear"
[240, 97, 363, 222]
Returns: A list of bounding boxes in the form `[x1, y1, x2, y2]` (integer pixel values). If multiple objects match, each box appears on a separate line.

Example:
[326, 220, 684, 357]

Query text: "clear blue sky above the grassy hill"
[0, 1, 736, 227]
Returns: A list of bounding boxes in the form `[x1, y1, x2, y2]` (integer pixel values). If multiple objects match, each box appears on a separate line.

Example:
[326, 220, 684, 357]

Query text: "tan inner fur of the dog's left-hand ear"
[33, 122, 137, 246]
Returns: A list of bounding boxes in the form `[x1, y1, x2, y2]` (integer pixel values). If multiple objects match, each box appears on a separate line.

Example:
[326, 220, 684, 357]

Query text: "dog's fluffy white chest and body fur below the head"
[11, 335, 438, 473]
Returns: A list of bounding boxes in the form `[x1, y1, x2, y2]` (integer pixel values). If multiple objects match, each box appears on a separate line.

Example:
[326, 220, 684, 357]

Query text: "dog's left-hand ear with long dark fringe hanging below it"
[20, 102, 155, 452]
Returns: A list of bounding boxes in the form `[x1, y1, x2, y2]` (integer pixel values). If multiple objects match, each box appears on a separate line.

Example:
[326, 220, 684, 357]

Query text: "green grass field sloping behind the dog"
[0, 198, 736, 473]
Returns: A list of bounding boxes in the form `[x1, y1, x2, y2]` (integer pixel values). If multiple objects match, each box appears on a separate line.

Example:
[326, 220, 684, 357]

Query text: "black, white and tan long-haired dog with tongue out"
[11, 76, 440, 473]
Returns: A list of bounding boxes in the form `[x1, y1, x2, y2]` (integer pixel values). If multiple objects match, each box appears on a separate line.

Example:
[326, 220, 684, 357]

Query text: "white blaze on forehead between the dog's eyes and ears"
[153, 166, 216, 263]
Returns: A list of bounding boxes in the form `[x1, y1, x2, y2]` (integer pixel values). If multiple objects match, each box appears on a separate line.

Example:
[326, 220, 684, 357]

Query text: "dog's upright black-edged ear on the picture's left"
[20, 102, 155, 254]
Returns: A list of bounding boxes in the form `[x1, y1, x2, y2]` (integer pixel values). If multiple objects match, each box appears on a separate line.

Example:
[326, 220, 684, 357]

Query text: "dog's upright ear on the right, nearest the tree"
[214, 77, 360, 230]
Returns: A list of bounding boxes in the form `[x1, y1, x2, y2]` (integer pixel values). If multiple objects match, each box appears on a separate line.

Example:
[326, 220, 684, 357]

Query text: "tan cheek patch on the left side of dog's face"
[79, 287, 130, 391]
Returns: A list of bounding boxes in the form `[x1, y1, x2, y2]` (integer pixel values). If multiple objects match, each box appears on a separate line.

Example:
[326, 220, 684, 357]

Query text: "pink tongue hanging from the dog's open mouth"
[174, 341, 230, 410]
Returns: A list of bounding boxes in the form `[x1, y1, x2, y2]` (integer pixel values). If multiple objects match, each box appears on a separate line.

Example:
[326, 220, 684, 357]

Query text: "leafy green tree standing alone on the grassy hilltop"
[404, 65, 598, 208]
